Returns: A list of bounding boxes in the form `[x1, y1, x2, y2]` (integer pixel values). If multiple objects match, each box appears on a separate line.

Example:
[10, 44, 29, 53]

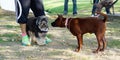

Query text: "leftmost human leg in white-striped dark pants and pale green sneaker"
[15, 0, 31, 45]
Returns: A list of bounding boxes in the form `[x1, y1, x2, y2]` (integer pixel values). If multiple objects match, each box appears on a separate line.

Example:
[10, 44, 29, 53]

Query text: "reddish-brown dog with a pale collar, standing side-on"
[51, 13, 108, 53]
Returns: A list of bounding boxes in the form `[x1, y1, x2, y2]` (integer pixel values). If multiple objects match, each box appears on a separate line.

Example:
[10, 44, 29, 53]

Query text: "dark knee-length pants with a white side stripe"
[15, 0, 45, 24]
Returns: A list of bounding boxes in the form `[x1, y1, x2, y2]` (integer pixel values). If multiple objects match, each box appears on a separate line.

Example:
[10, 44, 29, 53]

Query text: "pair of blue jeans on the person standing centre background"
[64, 0, 77, 14]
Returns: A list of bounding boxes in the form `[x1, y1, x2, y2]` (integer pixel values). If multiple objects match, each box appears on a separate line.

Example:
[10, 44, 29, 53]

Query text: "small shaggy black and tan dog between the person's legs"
[26, 16, 48, 45]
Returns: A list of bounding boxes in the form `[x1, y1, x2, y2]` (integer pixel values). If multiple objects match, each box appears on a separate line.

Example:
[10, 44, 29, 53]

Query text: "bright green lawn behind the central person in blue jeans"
[44, 0, 92, 14]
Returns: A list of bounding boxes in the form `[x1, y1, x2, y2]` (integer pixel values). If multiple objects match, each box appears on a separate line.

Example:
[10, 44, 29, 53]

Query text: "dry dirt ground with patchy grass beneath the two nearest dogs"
[0, 13, 120, 60]
